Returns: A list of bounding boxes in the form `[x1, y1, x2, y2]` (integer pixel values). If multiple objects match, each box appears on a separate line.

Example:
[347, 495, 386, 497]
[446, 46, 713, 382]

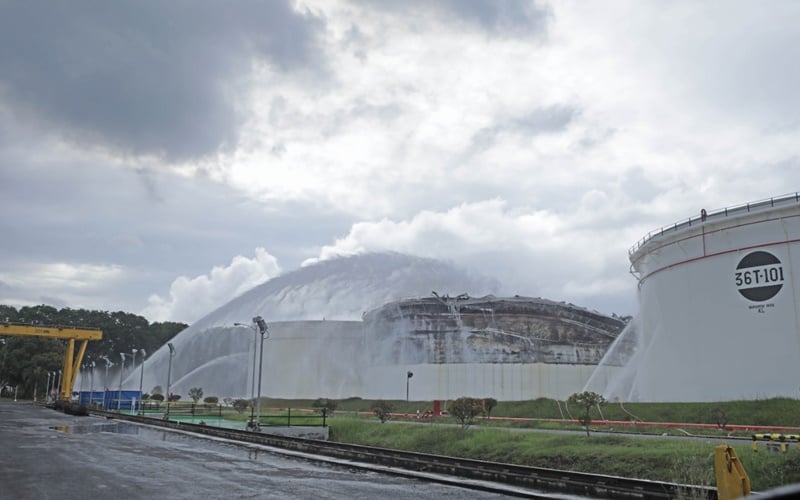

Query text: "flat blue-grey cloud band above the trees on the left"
[0, 157, 352, 311]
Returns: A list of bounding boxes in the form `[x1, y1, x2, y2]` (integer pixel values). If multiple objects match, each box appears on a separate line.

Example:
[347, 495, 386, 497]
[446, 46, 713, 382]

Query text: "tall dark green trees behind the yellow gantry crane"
[0, 305, 188, 398]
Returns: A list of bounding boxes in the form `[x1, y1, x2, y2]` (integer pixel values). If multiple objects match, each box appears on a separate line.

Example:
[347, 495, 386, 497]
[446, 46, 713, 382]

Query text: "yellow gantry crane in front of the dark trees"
[0, 323, 103, 400]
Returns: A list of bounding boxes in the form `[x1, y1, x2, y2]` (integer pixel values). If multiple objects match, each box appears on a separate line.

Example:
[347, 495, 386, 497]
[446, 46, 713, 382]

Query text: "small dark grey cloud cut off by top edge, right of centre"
[361, 0, 552, 36]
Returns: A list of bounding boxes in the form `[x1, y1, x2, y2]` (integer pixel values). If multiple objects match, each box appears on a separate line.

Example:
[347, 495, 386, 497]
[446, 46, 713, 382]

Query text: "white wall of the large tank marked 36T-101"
[629, 207, 800, 401]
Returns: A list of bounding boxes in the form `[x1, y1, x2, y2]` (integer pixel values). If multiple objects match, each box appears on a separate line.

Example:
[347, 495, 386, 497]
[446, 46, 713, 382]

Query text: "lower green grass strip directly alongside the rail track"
[330, 418, 800, 491]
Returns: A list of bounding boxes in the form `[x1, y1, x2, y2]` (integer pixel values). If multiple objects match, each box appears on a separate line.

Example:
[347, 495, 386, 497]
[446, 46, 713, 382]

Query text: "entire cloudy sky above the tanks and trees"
[0, 0, 800, 322]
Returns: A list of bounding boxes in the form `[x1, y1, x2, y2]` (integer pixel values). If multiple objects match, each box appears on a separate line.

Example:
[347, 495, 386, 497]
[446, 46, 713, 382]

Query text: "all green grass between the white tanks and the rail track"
[264, 398, 800, 491]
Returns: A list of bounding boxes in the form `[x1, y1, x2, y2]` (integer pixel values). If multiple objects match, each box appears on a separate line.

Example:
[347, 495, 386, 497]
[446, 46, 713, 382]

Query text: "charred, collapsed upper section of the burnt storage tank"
[364, 293, 625, 364]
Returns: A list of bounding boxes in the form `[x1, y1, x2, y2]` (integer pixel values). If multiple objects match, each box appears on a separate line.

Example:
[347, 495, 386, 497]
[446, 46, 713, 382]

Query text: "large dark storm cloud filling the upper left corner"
[0, 0, 321, 159]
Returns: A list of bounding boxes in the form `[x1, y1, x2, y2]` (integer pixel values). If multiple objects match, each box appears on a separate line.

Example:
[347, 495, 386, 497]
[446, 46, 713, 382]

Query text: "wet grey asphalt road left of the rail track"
[0, 401, 502, 500]
